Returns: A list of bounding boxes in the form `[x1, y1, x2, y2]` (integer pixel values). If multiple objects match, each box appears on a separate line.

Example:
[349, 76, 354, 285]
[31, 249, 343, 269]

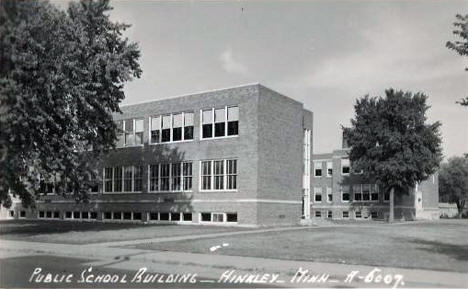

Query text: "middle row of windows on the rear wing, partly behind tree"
[314, 184, 390, 203]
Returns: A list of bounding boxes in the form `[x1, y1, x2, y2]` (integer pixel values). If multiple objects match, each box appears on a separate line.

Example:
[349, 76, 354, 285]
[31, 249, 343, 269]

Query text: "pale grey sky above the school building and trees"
[58, 0, 468, 157]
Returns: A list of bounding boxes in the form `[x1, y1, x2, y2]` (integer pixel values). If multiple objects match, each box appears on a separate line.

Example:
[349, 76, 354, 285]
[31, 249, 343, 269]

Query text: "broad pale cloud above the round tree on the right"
[304, 14, 463, 92]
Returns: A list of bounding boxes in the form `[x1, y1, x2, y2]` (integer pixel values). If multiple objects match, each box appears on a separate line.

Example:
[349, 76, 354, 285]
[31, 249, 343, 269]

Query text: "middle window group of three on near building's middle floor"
[148, 162, 192, 192]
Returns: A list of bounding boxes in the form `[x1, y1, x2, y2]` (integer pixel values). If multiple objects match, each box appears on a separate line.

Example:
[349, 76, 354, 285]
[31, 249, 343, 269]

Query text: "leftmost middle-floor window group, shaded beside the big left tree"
[104, 166, 143, 193]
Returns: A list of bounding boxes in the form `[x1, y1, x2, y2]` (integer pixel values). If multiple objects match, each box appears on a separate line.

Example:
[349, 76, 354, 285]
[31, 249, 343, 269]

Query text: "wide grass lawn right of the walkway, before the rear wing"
[131, 220, 468, 272]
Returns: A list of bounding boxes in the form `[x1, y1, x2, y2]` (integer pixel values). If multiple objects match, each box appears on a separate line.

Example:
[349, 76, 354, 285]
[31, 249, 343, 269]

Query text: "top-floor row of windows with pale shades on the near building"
[117, 106, 239, 147]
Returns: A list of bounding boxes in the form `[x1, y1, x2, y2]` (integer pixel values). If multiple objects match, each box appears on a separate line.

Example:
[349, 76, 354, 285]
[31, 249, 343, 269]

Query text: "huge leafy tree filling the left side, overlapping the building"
[0, 0, 141, 206]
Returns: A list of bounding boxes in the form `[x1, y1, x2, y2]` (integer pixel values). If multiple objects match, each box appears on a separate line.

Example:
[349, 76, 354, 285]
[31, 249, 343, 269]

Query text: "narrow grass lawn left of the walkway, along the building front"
[0, 220, 249, 244]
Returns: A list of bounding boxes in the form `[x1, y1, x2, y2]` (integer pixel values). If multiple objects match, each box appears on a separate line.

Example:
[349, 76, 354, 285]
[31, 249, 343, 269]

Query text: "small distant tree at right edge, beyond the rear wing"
[439, 155, 468, 218]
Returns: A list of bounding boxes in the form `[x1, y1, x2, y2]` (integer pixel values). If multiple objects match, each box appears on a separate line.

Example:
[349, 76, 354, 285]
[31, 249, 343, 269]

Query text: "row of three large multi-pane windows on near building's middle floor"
[101, 159, 237, 193]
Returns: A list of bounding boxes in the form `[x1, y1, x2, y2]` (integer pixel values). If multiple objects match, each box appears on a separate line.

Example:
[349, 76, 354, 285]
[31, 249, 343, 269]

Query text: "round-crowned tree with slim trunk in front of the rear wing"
[343, 89, 442, 222]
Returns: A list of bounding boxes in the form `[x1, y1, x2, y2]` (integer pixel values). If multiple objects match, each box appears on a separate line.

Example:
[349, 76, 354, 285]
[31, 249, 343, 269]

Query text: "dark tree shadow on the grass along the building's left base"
[0, 220, 174, 236]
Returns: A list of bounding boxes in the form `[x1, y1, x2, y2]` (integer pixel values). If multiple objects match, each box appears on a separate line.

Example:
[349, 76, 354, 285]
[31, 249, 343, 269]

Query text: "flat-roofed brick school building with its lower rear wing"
[2, 84, 438, 226]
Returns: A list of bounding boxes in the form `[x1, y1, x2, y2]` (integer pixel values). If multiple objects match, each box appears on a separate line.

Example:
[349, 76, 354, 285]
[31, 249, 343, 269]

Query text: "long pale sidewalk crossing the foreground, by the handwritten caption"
[0, 240, 468, 288]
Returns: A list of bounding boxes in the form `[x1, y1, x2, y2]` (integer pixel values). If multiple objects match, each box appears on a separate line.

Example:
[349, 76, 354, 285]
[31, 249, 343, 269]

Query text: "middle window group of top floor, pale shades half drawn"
[150, 112, 193, 144]
